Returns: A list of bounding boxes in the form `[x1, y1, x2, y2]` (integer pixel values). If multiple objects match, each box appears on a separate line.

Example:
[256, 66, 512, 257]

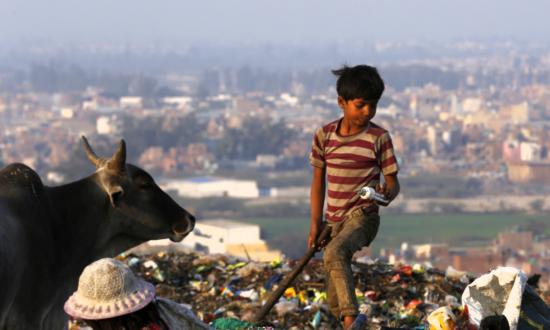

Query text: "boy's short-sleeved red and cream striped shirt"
[309, 119, 398, 222]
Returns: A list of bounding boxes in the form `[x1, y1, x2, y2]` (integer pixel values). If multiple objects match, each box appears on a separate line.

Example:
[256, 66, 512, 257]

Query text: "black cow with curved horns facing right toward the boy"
[0, 137, 195, 329]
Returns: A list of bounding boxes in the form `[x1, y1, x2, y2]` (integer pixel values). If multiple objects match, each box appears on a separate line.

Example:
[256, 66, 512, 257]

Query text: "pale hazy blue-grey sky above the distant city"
[0, 0, 550, 46]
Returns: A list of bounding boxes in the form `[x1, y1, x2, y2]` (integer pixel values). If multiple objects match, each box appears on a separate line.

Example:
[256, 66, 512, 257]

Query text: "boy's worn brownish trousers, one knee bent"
[323, 209, 380, 319]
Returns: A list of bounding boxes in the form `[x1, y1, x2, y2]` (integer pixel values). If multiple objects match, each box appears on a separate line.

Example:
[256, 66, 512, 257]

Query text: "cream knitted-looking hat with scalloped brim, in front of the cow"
[65, 258, 155, 320]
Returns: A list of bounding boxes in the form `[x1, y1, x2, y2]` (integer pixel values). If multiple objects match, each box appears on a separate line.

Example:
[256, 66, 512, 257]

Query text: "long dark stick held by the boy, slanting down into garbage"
[252, 226, 330, 323]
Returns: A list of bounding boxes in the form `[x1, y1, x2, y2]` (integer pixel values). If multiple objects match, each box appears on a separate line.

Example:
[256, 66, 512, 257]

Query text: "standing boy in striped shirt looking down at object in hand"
[308, 65, 399, 329]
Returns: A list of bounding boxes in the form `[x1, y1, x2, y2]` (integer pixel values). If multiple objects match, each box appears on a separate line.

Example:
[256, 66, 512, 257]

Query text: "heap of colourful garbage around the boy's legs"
[119, 252, 484, 329]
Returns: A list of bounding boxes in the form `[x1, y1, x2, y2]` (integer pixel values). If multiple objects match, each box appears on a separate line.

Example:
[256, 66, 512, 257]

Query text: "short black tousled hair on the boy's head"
[332, 65, 384, 102]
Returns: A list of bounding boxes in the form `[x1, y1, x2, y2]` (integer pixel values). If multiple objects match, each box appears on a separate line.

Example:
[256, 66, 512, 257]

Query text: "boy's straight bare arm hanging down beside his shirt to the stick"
[307, 167, 325, 248]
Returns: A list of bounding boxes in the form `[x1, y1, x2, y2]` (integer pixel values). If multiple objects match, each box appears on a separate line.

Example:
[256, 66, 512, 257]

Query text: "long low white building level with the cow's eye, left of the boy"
[160, 177, 260, 198]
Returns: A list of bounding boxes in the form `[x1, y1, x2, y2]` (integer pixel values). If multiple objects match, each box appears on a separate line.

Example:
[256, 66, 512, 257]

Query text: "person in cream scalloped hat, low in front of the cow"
[64, 258, 210, 330]
